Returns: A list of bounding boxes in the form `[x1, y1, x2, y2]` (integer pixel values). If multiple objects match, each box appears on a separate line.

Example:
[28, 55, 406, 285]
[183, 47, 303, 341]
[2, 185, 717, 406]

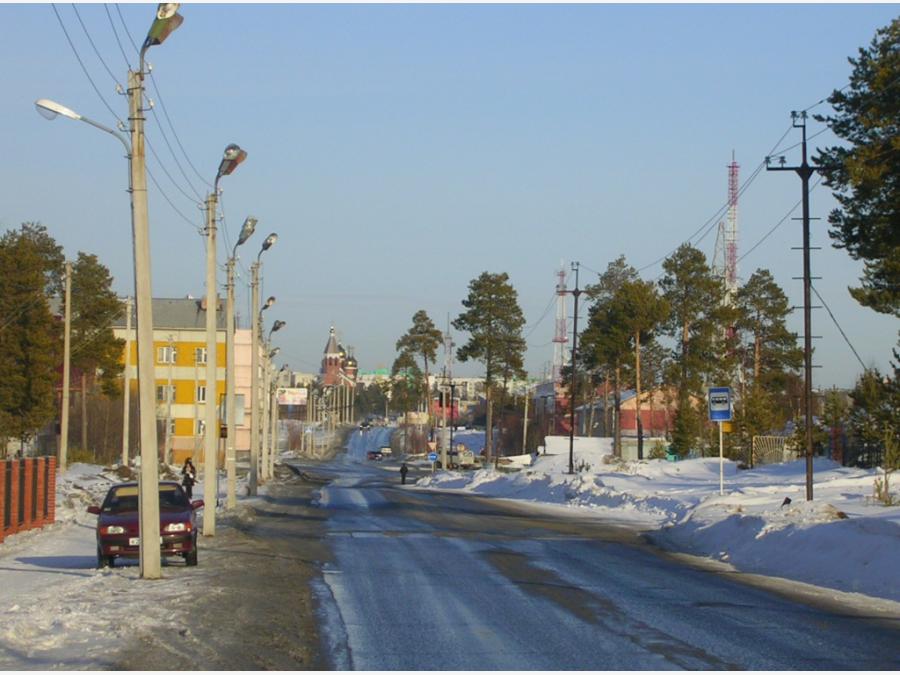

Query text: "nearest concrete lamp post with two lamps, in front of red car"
[36, 3, 184, 579]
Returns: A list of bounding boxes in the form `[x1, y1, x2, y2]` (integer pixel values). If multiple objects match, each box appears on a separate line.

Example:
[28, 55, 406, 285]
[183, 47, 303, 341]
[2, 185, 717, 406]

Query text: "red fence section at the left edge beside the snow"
[0, 457, 56, 541]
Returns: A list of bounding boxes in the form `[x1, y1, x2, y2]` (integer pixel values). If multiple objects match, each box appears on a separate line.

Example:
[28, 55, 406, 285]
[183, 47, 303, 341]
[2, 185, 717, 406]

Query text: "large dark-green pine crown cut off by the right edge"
[816, 19, 900, 316]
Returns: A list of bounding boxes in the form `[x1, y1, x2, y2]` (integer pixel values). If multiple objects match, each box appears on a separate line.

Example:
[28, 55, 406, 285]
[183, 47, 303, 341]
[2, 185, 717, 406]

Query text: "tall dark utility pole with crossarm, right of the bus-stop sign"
[766, 110, 819, 501]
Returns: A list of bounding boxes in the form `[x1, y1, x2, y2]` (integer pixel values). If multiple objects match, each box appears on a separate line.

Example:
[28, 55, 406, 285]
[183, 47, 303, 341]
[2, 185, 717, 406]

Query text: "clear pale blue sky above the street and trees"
[0, 4, 898, 386]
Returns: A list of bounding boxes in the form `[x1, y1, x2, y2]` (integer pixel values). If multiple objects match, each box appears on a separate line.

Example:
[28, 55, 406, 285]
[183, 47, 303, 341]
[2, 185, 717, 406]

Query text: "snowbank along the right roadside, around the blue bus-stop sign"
[417, 432, 900, 602]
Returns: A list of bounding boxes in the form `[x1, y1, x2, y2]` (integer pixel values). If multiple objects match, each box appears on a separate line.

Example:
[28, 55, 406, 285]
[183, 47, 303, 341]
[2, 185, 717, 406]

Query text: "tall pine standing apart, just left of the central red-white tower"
[453, 272, 525, 460]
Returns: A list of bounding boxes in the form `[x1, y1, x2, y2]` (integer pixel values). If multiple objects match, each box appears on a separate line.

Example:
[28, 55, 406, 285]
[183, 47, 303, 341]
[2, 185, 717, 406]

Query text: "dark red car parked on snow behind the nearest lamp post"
[88, 481, 203, 567]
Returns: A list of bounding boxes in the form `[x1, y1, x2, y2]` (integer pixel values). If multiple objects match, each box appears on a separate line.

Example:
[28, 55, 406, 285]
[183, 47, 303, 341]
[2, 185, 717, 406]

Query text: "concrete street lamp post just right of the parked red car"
[203, 143, 249, 537]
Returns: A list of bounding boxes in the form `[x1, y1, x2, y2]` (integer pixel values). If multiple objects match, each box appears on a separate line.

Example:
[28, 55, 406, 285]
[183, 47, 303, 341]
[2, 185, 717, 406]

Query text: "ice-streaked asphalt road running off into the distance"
[292, 430, 900, 670]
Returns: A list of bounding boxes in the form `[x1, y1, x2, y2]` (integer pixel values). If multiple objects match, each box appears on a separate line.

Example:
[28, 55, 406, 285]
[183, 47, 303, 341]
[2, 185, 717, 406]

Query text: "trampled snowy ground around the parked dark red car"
[0, 464, 265, 670]
